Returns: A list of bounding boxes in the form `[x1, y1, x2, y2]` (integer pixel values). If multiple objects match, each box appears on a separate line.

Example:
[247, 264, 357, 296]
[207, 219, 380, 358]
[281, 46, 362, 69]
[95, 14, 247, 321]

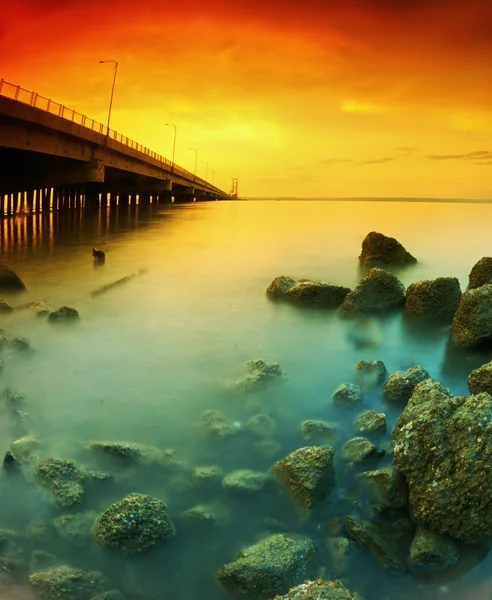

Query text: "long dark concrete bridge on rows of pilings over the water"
[0, 79, 231, 218]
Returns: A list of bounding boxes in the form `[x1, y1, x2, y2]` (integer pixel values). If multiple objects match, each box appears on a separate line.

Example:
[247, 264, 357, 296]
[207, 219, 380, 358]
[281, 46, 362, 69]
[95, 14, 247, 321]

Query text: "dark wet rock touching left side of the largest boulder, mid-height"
[356, 465, 408, 508]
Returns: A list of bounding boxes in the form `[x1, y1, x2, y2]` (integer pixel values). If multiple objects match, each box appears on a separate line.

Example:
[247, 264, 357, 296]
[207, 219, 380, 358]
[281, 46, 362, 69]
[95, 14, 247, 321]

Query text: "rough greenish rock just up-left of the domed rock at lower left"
[35, 458, 84, 506]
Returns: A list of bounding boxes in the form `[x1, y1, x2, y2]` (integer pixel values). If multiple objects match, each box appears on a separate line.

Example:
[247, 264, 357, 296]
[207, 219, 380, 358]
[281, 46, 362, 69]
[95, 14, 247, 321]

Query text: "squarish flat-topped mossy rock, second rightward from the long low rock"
[405, 277, 461, 323]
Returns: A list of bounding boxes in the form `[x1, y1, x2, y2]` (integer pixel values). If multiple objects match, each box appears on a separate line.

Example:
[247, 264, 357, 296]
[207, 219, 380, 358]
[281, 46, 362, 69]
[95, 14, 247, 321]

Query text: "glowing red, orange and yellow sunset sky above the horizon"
[0, 0, 492, 198]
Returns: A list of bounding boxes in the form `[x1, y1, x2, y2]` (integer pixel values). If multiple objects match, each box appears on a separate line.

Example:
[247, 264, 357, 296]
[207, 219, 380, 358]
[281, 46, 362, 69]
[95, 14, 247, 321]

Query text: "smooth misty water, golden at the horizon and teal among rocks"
[0, 200, 492, 600]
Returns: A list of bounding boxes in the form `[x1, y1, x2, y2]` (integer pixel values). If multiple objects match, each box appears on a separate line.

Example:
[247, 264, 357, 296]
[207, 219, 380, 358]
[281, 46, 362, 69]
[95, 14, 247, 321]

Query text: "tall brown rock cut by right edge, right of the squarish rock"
[451, 284, 492, 348]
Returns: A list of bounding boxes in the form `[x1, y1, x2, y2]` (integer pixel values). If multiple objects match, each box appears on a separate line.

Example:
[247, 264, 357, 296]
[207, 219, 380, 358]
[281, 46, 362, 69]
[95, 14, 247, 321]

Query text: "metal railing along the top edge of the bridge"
[0, 79, 220, 191]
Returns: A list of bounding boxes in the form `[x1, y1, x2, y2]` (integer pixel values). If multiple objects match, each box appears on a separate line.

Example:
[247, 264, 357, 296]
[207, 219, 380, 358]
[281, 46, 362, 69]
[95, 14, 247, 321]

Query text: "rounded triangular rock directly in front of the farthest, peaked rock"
[338, 267, 405, 315]
